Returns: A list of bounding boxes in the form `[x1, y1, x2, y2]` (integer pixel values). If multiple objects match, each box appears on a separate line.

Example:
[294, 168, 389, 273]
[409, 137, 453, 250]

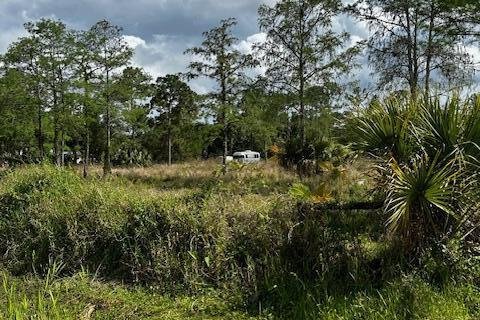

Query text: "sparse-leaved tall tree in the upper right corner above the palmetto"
[347, 0, 480, 97]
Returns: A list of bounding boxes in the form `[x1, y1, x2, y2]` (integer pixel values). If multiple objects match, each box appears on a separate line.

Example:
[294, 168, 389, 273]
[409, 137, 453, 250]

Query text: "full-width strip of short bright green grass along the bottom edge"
[0, 272, 480, 320]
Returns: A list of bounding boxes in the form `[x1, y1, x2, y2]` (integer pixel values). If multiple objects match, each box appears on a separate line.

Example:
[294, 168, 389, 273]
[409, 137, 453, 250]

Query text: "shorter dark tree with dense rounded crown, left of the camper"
[151, 75, 197, 165]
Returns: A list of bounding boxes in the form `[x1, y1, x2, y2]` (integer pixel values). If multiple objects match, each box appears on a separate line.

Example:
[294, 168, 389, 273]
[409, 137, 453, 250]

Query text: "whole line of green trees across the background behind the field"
[0, 0, 480, 175]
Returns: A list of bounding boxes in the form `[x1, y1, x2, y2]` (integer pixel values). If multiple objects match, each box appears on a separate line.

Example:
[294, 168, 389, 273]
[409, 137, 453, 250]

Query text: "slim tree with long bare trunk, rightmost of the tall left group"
[90, 20, 133, 175]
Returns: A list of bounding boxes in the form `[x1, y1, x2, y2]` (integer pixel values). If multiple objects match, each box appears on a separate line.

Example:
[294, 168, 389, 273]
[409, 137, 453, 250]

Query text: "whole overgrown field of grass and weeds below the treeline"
[0, 160, 480, 319]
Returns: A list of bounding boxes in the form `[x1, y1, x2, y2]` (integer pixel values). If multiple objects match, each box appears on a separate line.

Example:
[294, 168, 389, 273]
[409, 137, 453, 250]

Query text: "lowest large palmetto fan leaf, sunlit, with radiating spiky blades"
[386, 153, 457, 238]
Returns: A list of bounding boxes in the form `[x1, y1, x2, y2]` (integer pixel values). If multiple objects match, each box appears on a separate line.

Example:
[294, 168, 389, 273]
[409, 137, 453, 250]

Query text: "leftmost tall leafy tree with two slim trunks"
[4, 19, 79, 165]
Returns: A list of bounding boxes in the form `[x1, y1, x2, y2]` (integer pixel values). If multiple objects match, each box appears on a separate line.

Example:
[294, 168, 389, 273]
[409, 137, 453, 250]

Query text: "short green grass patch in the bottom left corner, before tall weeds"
[0, 273, 262, 320]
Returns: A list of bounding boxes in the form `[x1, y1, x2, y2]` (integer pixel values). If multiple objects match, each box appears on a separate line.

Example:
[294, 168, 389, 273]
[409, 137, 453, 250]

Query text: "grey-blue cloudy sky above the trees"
[0, 0, 376, 91]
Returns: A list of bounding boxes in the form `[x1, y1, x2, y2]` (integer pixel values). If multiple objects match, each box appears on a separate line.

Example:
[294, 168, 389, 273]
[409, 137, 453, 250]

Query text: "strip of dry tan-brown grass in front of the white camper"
[72, 158, 375, 202]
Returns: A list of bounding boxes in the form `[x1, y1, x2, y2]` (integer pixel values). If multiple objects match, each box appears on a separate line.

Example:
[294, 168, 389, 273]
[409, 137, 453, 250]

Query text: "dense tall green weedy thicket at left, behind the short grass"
[0, 166, 290, 288]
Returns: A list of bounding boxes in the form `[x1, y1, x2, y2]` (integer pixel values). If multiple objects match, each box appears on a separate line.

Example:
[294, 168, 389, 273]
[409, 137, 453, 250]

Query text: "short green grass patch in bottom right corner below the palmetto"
[316, 277, 480, 320]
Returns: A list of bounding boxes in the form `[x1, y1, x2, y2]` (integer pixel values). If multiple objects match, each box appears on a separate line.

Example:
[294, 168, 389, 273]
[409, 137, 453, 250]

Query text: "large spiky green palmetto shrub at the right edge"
[352, 96, 480, 254]
